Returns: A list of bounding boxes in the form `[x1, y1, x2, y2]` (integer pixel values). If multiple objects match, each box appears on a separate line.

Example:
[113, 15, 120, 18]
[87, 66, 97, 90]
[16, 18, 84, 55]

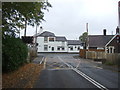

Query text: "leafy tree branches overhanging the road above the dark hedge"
[2, 1, 52, 36]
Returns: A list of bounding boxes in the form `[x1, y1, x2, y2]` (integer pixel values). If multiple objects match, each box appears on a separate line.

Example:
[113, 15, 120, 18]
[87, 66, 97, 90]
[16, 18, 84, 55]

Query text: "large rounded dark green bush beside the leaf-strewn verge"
[2, 36, 28, 72]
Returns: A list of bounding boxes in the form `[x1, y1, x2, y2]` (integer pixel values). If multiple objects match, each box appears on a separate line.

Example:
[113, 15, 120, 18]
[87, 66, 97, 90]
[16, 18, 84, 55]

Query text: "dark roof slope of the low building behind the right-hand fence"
[88, 35, 114, 47]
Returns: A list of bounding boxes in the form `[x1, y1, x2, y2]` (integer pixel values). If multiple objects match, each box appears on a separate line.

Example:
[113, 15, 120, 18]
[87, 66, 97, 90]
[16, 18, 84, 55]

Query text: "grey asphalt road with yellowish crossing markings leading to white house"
[34, 54, 118, 89]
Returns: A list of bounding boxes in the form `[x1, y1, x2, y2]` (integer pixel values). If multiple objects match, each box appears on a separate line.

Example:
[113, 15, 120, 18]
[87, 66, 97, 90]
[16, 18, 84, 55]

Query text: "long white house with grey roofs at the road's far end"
[37, 31, 82, 53]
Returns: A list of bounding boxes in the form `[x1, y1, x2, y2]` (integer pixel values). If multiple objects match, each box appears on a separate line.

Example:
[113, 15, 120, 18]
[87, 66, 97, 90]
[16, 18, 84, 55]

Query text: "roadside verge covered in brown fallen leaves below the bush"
[2, 63, 43, 88]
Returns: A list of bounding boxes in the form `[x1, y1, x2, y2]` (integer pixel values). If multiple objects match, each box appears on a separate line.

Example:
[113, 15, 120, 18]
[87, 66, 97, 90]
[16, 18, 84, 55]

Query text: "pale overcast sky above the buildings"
[21, 0, 119, 39]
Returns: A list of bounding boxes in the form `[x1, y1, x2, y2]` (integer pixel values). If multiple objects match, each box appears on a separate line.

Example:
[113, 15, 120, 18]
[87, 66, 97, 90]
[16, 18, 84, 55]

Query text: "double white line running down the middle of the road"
[58, 56, 108, 90]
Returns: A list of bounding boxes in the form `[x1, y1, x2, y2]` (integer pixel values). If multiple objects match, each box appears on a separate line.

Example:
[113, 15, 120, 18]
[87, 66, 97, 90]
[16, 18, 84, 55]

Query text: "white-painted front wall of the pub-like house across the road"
[37, 37, 83, 53]
